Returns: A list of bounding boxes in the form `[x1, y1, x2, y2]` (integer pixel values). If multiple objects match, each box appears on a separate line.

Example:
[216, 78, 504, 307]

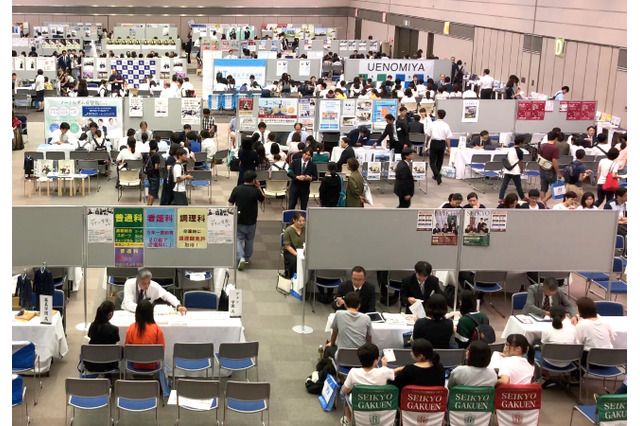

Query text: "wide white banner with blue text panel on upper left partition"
[44, 97, 124, 138]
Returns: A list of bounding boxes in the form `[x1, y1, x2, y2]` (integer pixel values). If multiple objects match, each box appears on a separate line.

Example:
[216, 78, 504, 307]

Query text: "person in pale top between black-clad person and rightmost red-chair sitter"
[447, 340, 498, 389]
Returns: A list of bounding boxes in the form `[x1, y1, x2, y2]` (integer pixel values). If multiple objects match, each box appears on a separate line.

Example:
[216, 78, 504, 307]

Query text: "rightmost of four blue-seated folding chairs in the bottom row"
[222, 380, 271, 425]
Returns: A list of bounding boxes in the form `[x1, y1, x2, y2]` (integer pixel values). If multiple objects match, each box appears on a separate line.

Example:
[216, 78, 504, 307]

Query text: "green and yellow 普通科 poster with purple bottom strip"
[113, 208, 144, 268]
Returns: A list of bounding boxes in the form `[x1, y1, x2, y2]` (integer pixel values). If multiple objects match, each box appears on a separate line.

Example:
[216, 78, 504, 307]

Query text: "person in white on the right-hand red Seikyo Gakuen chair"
[496, 334, 535, 386]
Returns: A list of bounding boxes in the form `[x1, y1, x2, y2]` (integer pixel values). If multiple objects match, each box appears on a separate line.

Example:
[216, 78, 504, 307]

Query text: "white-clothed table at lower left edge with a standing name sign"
[11, 311, 69, 372]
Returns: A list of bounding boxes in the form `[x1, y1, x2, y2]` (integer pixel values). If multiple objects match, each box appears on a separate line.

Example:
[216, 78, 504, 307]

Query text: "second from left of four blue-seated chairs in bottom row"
[115, 380, 160, 425]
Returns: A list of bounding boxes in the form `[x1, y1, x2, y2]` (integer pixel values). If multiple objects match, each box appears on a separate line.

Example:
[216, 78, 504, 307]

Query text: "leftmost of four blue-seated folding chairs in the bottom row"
[64, 377, 112, 426]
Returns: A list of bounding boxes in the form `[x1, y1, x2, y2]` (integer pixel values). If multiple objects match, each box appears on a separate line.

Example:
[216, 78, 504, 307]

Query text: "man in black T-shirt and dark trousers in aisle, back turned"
[229, 170, 264, 271]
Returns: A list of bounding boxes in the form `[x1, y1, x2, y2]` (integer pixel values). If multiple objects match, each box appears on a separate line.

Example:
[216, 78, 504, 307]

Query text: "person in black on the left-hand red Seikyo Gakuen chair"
[391, 339, 444, 392]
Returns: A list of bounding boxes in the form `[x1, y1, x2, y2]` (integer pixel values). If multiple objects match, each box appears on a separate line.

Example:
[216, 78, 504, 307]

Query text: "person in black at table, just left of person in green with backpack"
[412, 294, 457, 349]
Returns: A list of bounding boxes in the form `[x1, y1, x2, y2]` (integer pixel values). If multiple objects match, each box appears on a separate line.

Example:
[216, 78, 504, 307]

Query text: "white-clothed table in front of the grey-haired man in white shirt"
[110, 307, 244, 366]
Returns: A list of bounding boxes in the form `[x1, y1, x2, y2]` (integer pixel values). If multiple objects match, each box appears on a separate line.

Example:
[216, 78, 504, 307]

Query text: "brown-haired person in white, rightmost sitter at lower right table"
[576, 297, 616, 365]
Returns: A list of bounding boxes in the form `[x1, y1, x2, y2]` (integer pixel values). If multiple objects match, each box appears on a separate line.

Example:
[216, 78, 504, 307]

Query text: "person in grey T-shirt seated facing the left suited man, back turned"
[324, 291, 373, 358]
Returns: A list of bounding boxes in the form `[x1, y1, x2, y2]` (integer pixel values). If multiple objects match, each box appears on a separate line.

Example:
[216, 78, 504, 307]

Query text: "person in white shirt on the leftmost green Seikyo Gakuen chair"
[340, 343, 394, 425]
